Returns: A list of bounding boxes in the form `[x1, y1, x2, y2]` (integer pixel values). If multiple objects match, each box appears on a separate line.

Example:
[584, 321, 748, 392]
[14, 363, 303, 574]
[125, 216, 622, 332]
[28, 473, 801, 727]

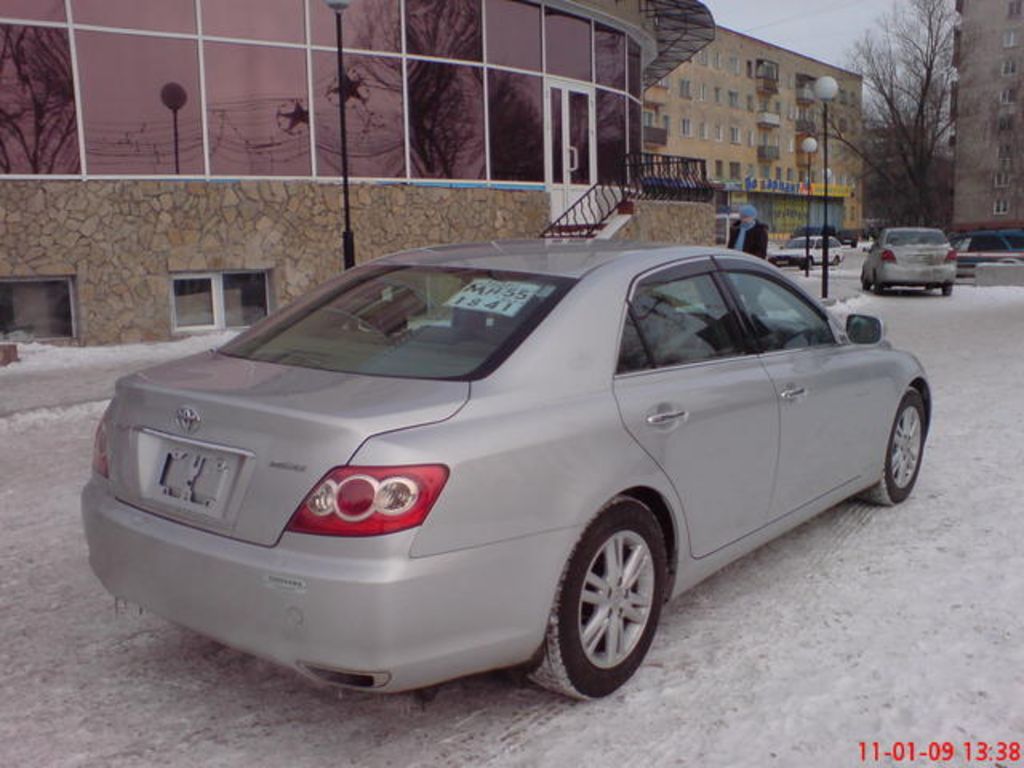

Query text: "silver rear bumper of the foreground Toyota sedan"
[82, 478, 578, 691]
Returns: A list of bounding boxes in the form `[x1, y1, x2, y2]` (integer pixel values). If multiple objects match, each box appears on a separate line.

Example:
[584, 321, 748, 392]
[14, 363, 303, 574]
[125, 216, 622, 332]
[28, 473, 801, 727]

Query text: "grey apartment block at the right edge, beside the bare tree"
[952, 0, 1024, 229]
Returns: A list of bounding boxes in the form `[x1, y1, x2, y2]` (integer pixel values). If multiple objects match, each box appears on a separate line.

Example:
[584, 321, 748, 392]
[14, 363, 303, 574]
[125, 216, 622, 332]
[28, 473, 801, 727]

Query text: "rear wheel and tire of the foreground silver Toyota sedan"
[530, 497, 668, 699]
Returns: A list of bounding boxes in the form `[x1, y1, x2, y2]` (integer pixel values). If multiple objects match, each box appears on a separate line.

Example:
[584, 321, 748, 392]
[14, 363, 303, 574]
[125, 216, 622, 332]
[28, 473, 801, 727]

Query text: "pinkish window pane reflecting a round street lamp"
[77, 32, 203, 174]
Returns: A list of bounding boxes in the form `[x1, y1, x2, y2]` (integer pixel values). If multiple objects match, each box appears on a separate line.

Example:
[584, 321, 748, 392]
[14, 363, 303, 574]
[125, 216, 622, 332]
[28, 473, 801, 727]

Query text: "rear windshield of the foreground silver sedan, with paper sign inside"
[220, 266, 572, 380]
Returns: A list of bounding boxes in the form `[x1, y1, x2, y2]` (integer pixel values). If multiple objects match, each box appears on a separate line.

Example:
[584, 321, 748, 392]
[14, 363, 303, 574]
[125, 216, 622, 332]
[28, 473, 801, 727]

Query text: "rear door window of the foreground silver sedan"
[618, 274, 743, 373]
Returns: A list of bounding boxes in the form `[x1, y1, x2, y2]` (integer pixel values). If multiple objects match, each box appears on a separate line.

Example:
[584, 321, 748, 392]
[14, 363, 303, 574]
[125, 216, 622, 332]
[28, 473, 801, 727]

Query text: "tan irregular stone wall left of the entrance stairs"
[0, 181, 549, 344]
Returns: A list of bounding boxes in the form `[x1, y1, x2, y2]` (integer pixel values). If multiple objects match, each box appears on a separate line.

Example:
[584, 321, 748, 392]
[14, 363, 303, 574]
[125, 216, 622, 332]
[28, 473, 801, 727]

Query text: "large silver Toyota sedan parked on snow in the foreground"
[82, 242, 931, 697]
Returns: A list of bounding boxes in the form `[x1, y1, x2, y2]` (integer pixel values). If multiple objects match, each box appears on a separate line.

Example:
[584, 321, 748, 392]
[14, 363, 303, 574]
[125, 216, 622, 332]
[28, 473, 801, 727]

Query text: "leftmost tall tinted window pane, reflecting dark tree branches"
[0, 25, 81, 173]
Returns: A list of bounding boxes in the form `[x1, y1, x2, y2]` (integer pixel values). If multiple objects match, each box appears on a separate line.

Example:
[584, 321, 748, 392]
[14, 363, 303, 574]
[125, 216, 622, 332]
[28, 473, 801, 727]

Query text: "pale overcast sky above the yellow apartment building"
[703, 0, 898, 67]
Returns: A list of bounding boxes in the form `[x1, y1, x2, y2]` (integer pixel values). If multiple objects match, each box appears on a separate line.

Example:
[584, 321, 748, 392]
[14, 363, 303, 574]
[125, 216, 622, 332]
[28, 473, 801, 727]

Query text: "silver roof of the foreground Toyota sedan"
[373, 238, 722, 279]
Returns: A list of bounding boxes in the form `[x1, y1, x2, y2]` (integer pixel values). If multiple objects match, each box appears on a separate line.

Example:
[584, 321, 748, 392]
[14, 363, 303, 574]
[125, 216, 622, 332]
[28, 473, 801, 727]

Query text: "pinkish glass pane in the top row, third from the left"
[203, 0, 306, 43]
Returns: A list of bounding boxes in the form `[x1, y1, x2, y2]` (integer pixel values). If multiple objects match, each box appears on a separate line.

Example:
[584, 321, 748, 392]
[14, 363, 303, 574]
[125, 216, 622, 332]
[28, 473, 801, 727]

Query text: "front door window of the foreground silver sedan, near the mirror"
[726, 272, 836, 352]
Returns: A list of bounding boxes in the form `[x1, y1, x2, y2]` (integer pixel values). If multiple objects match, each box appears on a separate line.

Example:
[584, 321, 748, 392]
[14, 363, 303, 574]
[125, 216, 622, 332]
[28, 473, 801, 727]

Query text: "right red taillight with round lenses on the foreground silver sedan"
[288, 464, 449, 536]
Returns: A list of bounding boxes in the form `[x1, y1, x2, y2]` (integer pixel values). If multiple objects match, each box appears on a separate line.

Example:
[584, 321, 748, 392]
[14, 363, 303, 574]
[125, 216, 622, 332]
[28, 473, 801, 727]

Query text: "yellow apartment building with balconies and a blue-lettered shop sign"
[644, 27, 863, 238]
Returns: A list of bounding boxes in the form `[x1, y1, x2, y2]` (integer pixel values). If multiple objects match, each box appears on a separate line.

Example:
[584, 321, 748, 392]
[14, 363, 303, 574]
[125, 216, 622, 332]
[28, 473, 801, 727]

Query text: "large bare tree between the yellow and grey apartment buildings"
[828, 0, 956, 226]
